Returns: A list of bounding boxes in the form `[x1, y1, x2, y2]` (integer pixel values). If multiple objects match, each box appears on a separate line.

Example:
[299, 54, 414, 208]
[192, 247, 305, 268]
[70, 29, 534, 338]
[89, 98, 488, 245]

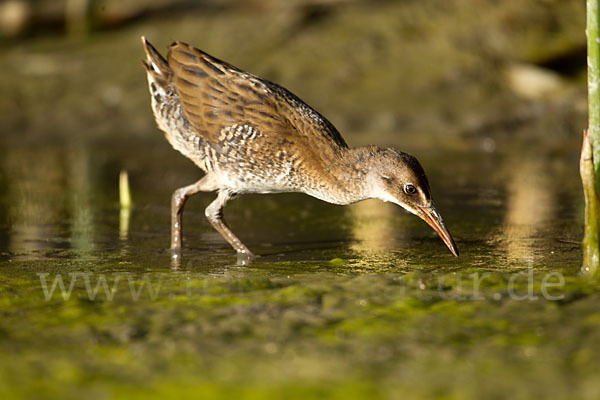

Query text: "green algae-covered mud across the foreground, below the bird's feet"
[0, 261, 600, 399]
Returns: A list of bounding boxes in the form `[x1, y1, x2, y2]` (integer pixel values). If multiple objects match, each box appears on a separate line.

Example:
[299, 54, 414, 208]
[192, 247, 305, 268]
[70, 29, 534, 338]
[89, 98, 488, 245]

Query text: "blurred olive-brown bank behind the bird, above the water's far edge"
[0, 0, 585, 149]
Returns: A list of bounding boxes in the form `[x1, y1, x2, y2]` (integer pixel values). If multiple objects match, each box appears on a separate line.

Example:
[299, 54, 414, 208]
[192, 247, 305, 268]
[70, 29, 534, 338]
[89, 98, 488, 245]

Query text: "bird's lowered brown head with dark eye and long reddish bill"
[368, 149, 458, 257]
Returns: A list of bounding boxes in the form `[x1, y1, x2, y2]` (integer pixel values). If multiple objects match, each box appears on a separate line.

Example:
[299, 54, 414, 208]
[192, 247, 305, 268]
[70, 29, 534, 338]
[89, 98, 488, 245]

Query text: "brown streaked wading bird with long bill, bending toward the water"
[141, 36, 458, 260]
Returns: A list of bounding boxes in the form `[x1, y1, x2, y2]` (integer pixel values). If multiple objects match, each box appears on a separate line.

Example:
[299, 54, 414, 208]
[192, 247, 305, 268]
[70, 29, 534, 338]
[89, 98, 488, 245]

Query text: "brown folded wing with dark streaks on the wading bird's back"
[167, 42, 347, 151]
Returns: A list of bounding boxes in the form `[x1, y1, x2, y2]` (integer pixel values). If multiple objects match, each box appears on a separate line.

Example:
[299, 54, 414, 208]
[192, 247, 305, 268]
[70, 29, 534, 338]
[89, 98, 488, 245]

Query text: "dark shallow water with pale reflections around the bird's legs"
[0, 139, 582, 272]
